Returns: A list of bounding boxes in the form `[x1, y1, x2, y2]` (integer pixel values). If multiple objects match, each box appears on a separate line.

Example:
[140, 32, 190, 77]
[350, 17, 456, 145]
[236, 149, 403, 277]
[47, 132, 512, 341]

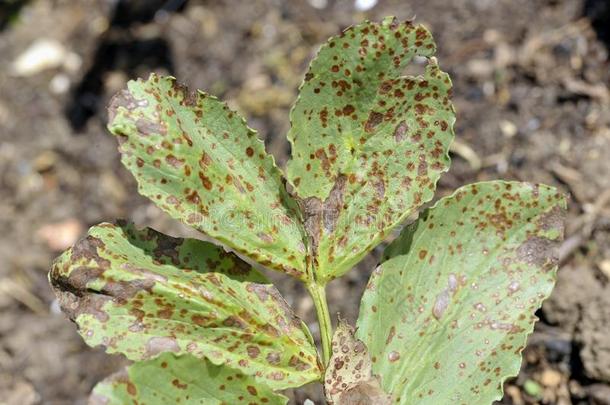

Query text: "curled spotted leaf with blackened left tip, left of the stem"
[50, 224, 320, 389]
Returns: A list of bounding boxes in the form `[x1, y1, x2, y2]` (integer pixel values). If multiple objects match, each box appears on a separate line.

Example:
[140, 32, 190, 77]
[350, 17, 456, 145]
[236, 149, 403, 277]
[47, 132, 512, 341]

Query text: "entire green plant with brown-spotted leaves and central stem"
[50, 18, 566, 405]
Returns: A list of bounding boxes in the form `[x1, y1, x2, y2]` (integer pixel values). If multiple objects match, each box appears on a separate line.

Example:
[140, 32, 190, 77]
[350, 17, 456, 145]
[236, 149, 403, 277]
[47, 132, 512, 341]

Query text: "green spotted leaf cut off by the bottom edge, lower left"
[89, 353, 288, 405]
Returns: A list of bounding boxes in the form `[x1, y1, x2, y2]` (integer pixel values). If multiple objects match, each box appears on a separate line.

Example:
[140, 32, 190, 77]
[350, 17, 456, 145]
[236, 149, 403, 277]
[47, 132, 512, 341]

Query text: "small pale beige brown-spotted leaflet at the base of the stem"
[324, 321, 392, 405]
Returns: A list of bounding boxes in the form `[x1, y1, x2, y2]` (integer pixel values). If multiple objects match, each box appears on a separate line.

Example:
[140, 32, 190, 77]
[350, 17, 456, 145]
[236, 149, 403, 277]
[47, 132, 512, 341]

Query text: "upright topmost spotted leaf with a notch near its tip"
[288, 18, 455, 281]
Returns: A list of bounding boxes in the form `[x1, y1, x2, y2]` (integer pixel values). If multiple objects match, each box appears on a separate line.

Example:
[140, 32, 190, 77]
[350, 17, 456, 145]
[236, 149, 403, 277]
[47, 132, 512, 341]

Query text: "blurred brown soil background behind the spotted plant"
[0, 0, 610, 405]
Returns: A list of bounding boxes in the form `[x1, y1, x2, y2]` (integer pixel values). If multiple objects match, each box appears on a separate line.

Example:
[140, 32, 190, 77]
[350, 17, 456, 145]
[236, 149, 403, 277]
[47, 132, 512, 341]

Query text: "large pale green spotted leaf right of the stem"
[356, 181, 566, 405]
